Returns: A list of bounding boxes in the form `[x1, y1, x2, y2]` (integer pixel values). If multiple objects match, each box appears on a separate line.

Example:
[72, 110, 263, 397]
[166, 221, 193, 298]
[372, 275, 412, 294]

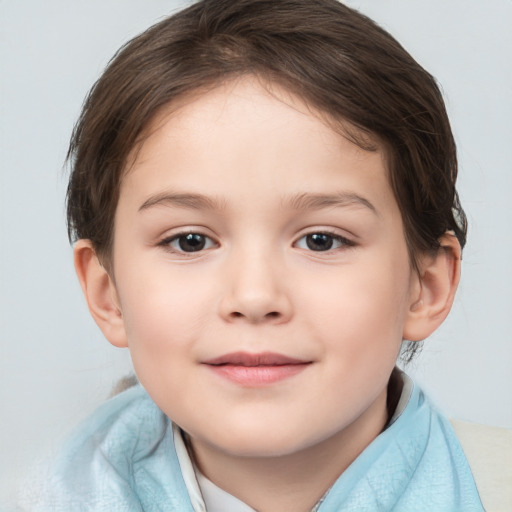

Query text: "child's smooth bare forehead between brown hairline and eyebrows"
[121, 77, 393, 219]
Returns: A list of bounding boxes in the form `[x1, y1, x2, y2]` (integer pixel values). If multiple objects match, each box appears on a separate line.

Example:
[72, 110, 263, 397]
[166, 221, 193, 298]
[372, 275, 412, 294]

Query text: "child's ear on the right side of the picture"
[403, 233, 461, 341]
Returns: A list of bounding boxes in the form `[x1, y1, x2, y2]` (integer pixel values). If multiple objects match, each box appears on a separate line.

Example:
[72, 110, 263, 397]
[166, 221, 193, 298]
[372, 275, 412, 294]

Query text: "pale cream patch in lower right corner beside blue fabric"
[450, 420, 512, 512]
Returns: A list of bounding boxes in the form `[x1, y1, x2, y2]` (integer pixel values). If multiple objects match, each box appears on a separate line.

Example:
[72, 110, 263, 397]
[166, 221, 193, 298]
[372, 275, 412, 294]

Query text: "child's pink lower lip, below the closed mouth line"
[208, 363, 309, 387]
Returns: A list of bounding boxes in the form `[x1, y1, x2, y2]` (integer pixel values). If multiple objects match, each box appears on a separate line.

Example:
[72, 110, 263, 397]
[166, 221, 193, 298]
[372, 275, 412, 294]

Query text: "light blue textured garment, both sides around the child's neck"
[33, 386, 484, 512]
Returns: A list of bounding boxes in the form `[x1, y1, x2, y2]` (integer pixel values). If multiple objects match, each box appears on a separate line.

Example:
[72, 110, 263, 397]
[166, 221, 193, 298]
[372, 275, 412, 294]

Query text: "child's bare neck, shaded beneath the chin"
[190, 390, 388, 512]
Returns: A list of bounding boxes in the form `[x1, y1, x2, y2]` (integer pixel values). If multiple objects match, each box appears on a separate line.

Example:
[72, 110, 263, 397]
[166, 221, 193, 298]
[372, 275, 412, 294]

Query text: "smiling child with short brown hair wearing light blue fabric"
[31, 0, 483, 512]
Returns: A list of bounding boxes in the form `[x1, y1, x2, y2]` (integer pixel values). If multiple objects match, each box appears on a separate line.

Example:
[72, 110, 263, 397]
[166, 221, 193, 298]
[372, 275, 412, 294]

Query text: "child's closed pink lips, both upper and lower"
[203, 352, 311, 387]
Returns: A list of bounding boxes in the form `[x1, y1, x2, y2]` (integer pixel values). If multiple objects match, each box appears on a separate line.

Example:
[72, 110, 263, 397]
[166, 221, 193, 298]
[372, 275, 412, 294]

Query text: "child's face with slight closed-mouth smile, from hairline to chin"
[109, 79, 419, 456]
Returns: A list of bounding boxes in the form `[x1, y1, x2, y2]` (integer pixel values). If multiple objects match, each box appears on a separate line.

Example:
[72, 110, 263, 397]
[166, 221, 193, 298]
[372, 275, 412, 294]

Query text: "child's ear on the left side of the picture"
[74, 240, 128, 347]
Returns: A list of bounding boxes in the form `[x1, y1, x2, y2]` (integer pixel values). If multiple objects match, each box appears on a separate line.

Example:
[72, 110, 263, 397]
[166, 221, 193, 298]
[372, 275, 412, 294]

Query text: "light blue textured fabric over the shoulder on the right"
[318, 385, 484, 512]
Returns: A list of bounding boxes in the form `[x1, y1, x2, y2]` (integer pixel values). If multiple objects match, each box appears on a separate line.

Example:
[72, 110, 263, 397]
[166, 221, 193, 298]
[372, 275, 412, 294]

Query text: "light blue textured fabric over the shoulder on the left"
[34, 386, 194, 512]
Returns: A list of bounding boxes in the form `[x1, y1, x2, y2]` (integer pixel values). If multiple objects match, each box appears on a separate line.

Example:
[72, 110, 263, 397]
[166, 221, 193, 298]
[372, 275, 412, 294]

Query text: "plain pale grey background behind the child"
[0, 0, 512, 503]
